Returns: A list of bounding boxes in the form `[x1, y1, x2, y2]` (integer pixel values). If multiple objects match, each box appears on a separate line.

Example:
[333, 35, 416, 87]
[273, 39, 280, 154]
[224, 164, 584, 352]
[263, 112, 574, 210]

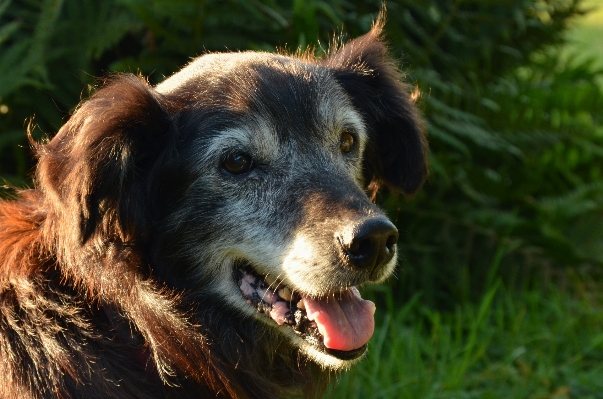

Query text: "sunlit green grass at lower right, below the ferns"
[328, 285, 603, 399]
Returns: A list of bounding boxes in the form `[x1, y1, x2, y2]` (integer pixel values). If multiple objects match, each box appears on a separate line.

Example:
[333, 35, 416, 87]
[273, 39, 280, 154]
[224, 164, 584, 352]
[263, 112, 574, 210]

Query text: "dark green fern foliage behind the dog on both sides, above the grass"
[0, 0, 603, 306]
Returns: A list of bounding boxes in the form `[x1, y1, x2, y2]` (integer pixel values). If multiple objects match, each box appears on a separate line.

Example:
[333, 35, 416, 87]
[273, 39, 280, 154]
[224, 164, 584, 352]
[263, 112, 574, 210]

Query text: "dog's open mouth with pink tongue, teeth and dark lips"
[234, 264, 375, 360]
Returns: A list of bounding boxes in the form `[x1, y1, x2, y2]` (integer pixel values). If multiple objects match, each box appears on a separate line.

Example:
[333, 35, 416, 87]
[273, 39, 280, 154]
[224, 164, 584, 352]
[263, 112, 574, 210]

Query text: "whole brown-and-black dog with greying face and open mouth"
[0, 18, 428, 399]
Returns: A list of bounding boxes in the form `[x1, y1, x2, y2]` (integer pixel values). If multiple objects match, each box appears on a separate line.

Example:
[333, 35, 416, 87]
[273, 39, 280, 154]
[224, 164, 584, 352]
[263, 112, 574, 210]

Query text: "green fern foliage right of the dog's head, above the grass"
[378, 1, 603, 306]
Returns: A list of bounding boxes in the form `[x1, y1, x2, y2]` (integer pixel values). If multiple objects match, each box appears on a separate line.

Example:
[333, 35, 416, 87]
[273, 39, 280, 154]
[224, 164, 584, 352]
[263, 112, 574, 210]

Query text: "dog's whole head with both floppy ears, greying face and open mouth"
[38, 24, 427, 368]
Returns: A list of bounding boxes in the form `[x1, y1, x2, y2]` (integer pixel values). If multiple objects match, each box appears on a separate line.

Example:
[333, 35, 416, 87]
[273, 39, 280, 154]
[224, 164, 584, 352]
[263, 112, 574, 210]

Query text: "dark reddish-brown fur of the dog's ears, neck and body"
[0, 18, 426, 399]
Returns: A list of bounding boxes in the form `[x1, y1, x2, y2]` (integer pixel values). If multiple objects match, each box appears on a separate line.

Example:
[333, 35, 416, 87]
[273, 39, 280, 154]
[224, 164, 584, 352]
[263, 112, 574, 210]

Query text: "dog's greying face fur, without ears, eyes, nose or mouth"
[157, 53, 396, 368]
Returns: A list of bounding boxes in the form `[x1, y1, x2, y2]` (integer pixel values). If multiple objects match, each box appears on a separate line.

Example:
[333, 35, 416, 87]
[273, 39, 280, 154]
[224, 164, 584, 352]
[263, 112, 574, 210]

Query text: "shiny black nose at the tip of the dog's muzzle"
[339, 216, 398, 270]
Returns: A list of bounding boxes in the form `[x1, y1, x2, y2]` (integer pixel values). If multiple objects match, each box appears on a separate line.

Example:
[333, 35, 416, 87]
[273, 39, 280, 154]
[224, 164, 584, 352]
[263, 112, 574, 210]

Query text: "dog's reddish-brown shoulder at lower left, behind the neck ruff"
[0, 190, 161, 399]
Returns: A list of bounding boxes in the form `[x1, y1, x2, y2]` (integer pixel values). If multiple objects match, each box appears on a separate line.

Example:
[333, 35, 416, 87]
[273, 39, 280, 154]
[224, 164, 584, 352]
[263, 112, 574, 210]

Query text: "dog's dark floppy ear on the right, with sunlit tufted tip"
[323, 15, 427, 195]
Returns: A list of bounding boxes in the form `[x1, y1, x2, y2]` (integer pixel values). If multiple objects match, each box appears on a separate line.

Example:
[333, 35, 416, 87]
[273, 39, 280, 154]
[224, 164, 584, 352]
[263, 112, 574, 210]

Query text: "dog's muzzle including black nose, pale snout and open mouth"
[233, 210, 398, 361]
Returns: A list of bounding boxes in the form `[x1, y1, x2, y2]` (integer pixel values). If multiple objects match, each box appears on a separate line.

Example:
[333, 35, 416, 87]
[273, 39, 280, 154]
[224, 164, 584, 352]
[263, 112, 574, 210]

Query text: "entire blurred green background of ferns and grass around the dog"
[0, 0, 603, 399]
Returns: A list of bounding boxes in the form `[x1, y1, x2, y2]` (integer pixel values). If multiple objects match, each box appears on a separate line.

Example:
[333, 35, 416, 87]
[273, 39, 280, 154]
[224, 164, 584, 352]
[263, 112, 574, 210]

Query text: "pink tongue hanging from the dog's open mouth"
[303, 287, 375, 351]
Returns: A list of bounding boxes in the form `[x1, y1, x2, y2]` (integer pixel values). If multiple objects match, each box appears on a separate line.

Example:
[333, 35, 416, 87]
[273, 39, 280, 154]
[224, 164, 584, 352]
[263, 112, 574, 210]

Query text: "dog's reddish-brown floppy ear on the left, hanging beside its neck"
[36, 74, 172, 244]
